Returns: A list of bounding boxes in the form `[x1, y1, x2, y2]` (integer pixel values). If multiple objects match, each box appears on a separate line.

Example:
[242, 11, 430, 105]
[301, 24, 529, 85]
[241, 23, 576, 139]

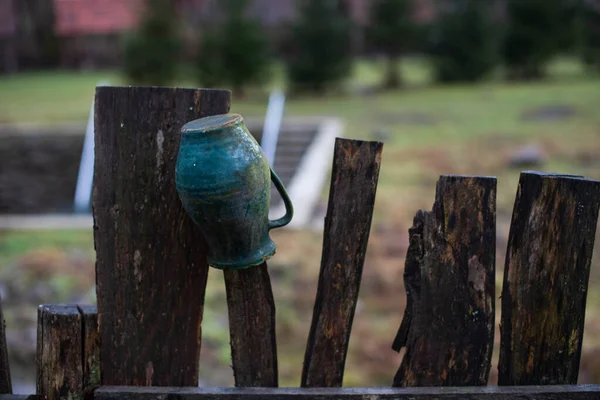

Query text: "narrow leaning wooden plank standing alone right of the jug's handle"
[301, 138, 383, 387]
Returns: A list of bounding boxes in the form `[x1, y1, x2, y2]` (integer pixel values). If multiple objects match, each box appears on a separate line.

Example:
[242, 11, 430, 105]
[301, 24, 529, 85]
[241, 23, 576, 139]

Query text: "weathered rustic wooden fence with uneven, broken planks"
[0, 87, 600, 400]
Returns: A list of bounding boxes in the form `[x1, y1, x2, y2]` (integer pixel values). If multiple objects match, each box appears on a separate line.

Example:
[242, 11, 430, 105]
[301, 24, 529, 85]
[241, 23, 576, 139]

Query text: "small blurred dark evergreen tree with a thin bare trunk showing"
[366, 0, 418, 89]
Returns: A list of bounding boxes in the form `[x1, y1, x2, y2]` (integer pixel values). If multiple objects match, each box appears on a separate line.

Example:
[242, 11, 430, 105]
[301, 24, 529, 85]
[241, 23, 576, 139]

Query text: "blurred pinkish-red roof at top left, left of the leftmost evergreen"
[54, 0, 144, 36]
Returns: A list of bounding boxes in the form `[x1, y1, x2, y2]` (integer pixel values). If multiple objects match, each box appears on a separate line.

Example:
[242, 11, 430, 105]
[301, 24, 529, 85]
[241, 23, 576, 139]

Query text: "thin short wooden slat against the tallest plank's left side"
[77, 305, 100, 400]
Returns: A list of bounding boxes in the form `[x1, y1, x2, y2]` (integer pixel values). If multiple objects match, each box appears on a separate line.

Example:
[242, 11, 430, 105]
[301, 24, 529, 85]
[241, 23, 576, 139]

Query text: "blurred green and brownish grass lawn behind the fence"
[0, 59, 600, 386]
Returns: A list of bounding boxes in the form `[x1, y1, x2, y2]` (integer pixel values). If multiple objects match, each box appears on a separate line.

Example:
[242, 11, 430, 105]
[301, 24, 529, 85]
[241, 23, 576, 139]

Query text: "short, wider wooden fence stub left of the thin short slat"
[37, 305, 83, 400]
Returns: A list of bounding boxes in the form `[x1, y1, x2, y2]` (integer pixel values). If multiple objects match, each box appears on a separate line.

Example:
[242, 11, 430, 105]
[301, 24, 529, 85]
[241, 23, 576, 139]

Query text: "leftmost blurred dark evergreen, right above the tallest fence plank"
[124, 0, 182, 86]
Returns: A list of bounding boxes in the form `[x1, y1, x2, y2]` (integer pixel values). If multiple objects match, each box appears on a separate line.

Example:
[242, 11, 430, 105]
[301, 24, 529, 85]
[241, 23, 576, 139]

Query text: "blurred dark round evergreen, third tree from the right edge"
[429, 0, 499, 82]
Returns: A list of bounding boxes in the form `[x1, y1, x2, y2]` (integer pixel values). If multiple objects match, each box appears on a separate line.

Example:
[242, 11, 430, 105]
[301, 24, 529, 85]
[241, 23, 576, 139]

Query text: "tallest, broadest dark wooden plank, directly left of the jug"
[92, 87, 230, 386]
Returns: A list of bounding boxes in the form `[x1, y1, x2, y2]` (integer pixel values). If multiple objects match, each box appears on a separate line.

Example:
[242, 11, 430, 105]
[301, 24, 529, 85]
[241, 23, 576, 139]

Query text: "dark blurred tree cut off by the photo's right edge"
[580, 0, 600, 71]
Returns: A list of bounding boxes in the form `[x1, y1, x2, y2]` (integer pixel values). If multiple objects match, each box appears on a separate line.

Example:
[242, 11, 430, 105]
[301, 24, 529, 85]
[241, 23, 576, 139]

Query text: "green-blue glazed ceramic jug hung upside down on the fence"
[175, 114, 294, 269]
